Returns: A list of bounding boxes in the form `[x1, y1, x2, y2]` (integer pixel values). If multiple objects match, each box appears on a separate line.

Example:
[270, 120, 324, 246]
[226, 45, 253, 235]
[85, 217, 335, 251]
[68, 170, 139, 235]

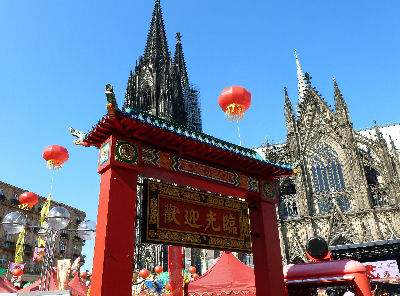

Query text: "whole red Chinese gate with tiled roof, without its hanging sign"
[81, 110, 293, 296]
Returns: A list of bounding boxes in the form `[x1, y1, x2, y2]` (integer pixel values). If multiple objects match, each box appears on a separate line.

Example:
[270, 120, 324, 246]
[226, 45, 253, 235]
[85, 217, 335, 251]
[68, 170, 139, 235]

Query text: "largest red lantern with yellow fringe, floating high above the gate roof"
[218, 86, 251, 121]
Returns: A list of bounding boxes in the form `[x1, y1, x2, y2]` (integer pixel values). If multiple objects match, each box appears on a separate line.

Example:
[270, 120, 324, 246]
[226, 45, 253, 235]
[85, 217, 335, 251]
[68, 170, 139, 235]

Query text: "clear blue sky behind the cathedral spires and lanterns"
[0, 0, 400, 269]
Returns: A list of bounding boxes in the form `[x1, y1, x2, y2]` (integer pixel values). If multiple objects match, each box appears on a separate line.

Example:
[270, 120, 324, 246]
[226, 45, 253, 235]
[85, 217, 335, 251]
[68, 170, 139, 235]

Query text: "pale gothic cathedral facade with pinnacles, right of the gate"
[260, 56, 400, 264]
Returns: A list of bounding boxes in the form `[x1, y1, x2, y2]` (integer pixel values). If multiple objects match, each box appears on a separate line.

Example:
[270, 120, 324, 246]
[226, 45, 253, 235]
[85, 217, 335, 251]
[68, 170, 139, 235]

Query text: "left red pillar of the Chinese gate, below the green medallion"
[91, 165, 138, 296]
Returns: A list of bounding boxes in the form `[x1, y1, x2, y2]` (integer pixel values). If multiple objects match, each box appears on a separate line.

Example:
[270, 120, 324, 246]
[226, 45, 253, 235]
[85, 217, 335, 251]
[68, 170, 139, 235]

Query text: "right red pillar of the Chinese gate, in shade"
[248, 194, 285, 296]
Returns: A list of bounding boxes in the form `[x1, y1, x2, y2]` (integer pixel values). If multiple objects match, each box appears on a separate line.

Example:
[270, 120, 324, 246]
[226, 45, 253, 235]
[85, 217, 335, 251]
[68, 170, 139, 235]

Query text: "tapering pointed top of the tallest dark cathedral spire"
[144, 0, 169, 65]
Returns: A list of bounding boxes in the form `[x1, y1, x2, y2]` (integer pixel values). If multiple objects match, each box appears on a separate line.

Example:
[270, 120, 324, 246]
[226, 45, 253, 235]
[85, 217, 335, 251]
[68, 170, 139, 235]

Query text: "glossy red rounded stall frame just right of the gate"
[283, 260, 372, 296]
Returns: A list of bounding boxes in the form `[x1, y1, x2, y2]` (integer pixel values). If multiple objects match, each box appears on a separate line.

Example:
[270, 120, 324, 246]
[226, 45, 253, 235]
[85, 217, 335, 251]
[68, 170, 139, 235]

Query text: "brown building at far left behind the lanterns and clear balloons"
[0, 181, 86, 281]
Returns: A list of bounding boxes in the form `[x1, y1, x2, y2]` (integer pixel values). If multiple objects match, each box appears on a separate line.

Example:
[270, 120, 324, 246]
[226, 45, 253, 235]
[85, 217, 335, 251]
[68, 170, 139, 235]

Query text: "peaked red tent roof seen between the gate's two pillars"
[185, 252, 256, 296]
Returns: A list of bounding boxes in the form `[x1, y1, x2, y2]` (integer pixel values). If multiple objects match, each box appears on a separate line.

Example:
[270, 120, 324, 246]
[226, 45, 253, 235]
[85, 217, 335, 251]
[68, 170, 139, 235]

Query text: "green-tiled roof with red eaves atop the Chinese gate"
[82, 112, 293, 178]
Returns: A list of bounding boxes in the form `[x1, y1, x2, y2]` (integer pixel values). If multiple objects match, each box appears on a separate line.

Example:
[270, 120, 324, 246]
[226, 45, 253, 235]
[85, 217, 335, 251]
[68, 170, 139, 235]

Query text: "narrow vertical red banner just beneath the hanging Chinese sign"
[168, 246, 183, 296]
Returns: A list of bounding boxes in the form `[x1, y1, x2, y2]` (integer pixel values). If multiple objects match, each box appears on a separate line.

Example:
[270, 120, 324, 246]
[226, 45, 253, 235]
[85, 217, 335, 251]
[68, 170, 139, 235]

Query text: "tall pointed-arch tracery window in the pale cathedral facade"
[310, 142, 350, 214]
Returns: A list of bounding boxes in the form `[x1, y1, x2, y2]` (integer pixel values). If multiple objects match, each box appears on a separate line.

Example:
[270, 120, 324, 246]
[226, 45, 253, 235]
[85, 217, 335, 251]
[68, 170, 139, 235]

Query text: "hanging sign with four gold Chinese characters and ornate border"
[142, 180, 251, 253]
